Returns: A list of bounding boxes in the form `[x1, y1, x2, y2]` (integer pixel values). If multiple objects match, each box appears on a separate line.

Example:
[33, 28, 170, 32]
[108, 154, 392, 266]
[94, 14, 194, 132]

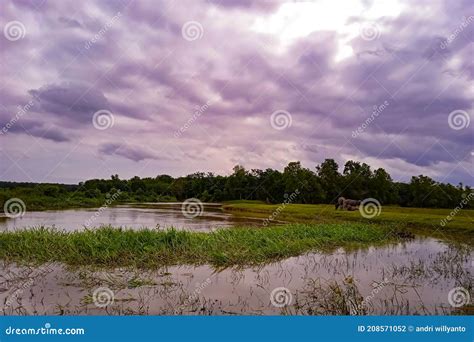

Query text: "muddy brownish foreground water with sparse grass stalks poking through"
[0, 238, 474, 315]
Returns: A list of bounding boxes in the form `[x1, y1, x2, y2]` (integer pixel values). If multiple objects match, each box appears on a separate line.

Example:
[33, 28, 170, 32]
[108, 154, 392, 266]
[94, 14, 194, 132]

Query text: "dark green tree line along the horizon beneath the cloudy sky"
[0, 159, 473, 209]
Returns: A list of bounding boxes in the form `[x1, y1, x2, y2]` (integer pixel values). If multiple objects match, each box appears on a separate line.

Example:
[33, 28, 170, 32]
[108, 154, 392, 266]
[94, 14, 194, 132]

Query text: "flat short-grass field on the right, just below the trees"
[224, 201, 474, 243]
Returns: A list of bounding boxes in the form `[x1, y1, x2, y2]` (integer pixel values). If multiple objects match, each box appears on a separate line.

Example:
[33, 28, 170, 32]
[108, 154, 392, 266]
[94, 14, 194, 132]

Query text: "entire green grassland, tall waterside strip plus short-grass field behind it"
[0, 201, 474, 268]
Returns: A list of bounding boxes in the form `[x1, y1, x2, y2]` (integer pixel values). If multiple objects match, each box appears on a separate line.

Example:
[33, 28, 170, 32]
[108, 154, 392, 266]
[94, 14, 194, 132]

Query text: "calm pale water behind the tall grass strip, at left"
[0, 203, 262, 231]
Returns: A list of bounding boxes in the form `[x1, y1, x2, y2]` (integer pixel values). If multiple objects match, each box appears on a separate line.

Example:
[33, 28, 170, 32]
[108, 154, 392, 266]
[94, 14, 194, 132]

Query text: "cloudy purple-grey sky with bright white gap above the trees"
[0, 0, 474, 185]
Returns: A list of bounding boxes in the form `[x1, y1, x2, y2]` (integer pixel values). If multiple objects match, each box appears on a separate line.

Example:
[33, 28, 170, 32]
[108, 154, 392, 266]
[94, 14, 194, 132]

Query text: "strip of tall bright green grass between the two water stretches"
[0, 223, 394, 268]
